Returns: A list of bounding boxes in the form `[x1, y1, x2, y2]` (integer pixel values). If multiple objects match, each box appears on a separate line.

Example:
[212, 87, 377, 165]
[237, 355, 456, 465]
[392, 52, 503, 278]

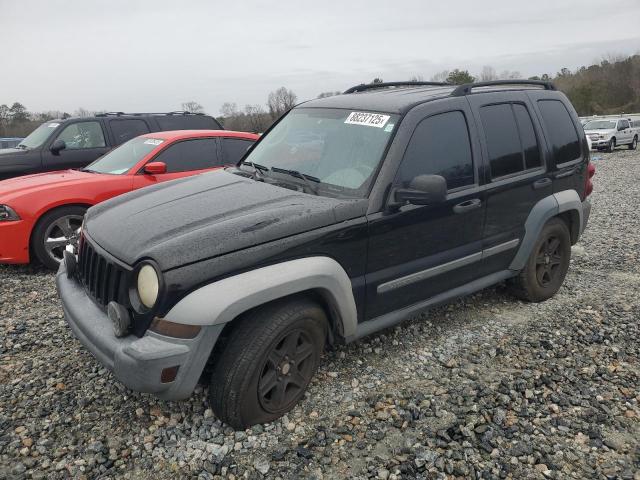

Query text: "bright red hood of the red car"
[0, 170, 100, 203]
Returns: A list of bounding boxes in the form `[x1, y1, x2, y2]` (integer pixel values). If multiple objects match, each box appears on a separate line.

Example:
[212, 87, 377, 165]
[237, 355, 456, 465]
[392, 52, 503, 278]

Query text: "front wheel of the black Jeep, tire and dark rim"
[209, 298, 327, 429]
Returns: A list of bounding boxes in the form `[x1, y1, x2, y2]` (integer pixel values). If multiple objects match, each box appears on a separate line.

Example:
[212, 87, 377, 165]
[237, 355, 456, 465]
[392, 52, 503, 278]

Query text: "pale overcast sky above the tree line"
[0, 0, 640, 115]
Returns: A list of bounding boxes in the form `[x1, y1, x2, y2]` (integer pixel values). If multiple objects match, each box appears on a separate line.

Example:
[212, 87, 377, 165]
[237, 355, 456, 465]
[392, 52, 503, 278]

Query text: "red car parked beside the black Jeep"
[0, 130, 258, 269]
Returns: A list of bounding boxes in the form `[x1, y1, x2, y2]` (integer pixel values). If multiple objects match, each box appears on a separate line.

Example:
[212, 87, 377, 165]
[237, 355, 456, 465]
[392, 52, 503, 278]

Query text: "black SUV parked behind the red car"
[0, 112, 222, 180]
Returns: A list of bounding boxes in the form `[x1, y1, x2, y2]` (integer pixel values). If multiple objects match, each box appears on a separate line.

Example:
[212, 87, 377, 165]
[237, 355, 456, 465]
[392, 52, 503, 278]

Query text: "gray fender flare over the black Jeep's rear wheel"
[509, 190, 584, 271]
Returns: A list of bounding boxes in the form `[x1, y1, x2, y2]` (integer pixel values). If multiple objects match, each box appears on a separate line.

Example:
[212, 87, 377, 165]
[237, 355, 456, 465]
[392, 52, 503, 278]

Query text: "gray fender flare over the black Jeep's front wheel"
[166, 257, 358, 337]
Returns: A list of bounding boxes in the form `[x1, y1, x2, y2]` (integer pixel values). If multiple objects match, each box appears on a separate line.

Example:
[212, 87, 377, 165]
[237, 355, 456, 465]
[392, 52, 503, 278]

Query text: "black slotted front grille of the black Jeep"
[78, 236, 128, 307]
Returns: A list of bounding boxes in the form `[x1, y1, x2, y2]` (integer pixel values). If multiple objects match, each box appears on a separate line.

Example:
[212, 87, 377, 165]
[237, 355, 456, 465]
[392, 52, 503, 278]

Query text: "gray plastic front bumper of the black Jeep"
[56, 262, 224, 400]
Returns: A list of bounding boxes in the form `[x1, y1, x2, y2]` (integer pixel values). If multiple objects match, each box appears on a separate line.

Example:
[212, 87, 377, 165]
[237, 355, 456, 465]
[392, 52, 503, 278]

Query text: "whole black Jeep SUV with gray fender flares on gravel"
[56, 81, 594, 428]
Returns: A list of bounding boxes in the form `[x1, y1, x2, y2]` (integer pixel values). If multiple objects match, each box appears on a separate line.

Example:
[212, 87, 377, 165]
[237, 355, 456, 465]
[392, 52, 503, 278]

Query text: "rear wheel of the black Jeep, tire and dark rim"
[509, 218, 571, 302]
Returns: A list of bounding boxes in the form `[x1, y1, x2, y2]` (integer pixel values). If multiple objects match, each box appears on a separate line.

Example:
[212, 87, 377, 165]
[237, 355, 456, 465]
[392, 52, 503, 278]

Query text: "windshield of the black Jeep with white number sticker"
[244, 108, 398, 197]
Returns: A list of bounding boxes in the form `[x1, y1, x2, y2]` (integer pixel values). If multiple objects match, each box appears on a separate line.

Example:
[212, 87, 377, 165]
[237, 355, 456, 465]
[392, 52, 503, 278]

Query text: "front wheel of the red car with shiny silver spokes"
[31, 205, 87, 270]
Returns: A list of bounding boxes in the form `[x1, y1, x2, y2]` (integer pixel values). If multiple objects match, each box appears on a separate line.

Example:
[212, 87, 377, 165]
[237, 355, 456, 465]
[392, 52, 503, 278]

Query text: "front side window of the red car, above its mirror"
[152, 138, 220, 173]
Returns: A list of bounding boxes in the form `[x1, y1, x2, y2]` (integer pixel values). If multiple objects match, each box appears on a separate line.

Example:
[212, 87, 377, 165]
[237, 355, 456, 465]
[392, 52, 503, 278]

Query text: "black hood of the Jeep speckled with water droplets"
[85, 171, 364, 270]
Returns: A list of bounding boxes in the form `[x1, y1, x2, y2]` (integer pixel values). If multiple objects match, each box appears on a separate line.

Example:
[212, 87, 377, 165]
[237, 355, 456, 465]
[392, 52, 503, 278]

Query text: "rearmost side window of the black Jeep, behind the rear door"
[538, 100, 580, 164]
